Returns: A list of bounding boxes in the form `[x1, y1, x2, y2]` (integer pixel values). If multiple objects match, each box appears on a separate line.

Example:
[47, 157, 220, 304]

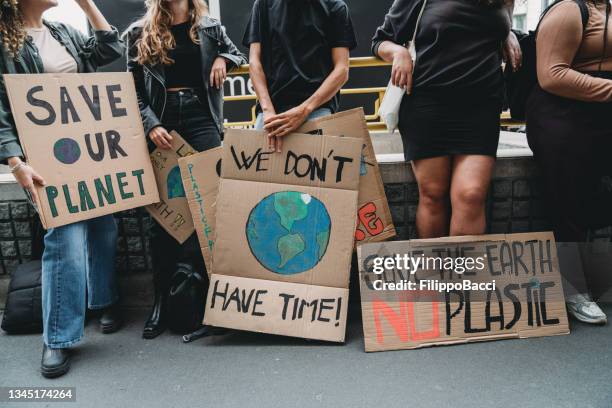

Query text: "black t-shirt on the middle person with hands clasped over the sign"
[243, 0, 357, 113]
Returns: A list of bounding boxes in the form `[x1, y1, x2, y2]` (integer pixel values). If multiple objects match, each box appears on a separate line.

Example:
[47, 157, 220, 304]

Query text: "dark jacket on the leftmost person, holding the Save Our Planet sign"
[0, 21, 124, 163]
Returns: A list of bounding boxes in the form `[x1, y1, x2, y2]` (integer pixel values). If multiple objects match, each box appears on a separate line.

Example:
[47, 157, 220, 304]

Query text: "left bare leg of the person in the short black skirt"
[412, 157, 451, 238]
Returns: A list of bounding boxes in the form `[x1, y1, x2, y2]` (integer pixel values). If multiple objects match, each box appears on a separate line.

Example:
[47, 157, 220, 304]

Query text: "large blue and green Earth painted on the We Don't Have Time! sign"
[246, 191, 331, 275]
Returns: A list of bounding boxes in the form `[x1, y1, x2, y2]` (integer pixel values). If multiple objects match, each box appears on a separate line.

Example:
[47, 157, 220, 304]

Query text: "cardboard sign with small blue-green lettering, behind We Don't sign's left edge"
[179, 147, 223, 277]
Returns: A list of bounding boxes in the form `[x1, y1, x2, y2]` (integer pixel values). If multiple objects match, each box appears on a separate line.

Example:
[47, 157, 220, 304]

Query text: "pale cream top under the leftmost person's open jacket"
[27, 27, 78, 74]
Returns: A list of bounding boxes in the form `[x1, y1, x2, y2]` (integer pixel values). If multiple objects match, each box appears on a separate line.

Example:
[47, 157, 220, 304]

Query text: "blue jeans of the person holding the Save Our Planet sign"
[42, 215, 118, 348]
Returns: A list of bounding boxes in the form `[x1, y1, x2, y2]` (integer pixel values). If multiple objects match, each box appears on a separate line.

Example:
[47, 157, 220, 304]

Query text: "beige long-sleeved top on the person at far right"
[536, 0, 612, 102]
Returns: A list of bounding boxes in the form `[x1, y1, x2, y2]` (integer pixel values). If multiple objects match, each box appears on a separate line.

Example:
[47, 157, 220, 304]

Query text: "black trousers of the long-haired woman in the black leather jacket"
[151, 90, 221, 280]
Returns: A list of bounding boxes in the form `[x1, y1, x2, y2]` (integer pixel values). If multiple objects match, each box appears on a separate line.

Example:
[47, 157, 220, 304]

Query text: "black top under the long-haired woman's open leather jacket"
[165, 22, 204, 89]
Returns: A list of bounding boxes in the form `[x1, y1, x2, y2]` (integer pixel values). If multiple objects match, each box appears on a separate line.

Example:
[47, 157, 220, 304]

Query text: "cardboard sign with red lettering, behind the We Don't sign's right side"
[298, 108, 395, 245]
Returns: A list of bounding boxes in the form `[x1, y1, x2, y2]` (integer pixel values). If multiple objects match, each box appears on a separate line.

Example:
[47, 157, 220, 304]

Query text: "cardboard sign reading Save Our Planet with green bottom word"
[4, 72, 159, 228]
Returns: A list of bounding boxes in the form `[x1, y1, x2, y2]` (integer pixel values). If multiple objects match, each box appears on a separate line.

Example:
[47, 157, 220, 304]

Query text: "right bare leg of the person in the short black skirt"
[450, 155, 495, 236]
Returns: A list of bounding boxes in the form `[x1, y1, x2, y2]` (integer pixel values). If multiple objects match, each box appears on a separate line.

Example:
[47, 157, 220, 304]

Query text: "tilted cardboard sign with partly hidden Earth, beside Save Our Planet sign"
[146, 131, 197, 244]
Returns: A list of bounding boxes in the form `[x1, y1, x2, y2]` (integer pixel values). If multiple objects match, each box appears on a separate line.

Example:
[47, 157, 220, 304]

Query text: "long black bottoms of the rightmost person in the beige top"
[526, 87, 612, 294]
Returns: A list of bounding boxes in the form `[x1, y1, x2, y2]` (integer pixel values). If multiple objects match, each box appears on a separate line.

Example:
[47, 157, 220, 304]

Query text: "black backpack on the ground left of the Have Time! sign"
[167, 263, 207, 334]
